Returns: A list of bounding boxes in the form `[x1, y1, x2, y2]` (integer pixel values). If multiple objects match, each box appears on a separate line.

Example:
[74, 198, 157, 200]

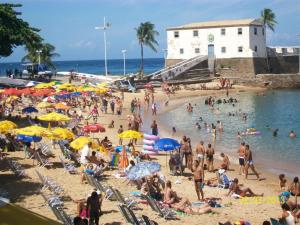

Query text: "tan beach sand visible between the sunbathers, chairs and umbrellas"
[0, 78, 292, 225]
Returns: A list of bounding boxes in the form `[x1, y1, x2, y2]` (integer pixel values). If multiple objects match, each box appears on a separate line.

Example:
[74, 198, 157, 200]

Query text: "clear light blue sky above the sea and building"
[0, 0, 300, 62]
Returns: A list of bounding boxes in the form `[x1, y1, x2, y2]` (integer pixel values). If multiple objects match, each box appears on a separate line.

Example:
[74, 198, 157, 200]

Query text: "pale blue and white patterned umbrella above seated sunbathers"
[127, 162, 161, 180]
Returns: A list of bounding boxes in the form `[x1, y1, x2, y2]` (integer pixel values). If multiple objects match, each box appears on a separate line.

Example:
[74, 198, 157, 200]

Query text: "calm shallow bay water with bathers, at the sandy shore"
[160, 90, 300, 176]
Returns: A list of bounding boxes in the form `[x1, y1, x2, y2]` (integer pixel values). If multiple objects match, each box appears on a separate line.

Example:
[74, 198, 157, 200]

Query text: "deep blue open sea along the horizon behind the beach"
[0, 58, 164, 75]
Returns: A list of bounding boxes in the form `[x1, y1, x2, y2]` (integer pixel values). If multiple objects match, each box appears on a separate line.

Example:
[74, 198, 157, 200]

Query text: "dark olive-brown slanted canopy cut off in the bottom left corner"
[0, 198, 62, 225]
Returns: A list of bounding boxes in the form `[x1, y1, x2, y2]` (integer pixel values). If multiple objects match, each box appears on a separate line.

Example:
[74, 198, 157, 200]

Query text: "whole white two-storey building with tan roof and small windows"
[167, 19, 266, 61]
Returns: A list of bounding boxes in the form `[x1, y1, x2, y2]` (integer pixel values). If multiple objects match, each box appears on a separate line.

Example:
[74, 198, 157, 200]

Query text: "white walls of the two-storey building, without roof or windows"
[167, 26, 266, 59]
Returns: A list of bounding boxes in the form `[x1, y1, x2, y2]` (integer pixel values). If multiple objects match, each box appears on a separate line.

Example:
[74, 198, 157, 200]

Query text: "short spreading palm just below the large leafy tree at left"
[22, 43, 60, 68]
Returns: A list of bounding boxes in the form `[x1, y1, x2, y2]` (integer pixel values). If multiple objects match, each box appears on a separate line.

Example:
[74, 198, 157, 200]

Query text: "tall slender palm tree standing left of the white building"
[135, 22, 159, 75]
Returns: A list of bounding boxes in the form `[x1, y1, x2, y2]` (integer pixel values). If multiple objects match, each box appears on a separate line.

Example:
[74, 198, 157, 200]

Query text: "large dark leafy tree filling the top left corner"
[0, 3, 43, 58]
